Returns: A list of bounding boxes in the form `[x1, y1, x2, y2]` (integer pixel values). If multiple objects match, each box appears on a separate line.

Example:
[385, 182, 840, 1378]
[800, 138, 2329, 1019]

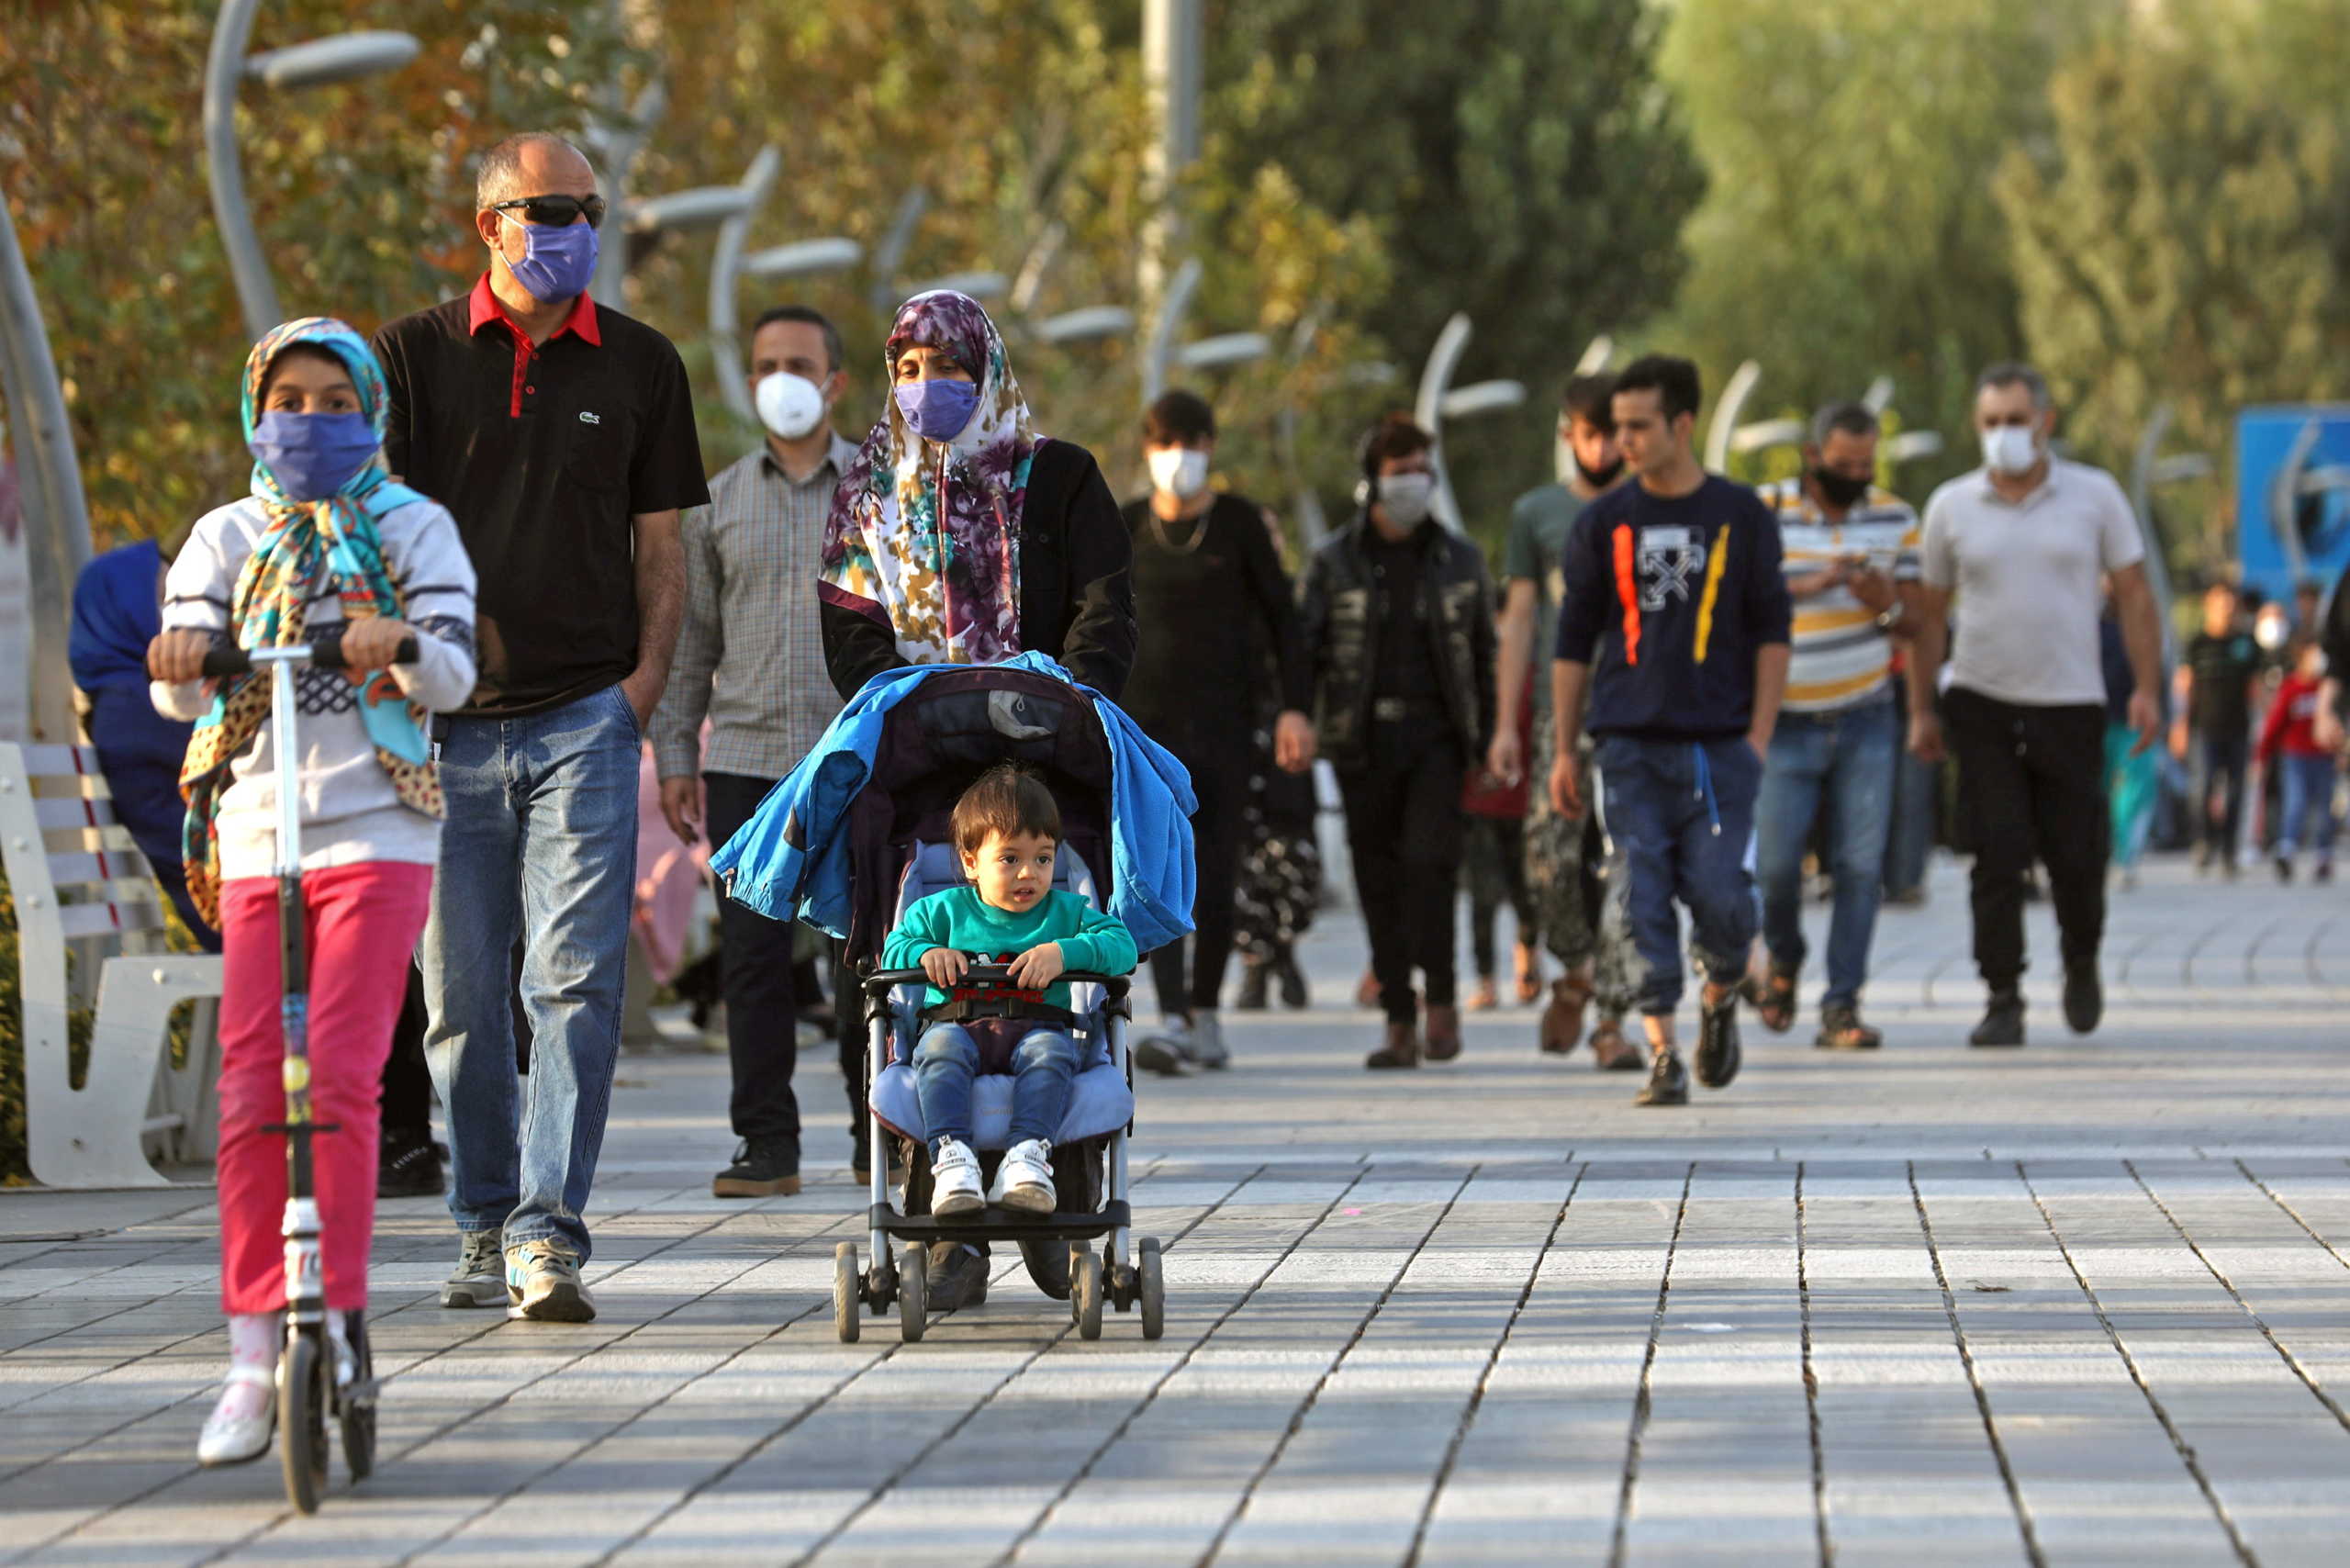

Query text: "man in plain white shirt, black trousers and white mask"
[1910, 364, 2162, 1047]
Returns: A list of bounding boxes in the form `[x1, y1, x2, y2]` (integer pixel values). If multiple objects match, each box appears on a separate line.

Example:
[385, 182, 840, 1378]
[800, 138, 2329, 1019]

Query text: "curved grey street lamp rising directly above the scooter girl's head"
[205, 0, 423, 339]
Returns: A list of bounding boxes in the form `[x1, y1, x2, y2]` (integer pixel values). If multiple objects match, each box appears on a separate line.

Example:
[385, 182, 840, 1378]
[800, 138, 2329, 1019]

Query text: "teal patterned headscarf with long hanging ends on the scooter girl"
[179, 315, 442, 926]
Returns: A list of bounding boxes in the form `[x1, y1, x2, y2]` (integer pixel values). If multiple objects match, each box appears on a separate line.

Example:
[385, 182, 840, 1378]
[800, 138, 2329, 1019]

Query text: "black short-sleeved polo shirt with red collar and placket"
[376, 273, 710, 717]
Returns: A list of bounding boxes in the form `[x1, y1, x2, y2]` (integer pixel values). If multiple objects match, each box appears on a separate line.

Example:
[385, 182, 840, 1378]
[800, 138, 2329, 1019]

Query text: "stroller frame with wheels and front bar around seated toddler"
[832, 964, 1166, 1345]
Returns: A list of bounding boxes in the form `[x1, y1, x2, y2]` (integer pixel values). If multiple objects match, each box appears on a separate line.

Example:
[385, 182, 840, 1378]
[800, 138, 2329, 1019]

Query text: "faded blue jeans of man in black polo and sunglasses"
[420, 687, 642, 1260]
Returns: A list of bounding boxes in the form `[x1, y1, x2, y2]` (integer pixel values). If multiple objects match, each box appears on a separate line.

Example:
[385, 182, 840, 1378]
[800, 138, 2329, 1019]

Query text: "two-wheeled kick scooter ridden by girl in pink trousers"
[205, 637, 416, 1514]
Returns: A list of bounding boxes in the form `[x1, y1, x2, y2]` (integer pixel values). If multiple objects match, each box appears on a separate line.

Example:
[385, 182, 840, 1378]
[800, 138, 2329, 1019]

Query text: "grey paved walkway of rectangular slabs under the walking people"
[0, 868, 2350, 1568]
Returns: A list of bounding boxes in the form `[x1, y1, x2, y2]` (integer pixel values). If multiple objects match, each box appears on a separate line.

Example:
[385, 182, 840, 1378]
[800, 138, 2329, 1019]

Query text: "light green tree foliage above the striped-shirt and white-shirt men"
[1654, 0, 2085, 498]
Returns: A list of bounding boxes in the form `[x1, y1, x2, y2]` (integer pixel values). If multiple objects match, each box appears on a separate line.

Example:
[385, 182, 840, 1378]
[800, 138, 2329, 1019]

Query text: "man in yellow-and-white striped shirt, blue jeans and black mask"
[1746, 402, 1925, 1051]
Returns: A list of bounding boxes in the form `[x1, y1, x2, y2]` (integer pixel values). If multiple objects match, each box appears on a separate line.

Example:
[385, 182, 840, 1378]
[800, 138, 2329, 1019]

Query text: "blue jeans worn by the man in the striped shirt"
[1755, 700, 1901, 1009]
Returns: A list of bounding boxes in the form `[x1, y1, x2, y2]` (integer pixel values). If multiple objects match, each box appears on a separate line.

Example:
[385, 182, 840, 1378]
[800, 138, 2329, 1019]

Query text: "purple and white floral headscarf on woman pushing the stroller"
[818, 289, 1039, 666]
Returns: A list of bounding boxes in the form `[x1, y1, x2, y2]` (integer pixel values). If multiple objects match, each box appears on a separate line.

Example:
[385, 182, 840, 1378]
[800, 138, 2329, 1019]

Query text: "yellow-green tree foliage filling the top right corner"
[1995, 0, 2350, 566]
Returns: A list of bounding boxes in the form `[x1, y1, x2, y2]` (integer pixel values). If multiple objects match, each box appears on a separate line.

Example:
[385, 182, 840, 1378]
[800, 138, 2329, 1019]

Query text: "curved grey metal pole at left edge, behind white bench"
[0, 202, 89, 741]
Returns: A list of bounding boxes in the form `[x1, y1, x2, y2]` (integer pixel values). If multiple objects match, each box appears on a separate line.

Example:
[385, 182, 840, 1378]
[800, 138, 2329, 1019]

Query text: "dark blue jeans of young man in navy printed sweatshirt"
[1595, 736, 1762, 1018]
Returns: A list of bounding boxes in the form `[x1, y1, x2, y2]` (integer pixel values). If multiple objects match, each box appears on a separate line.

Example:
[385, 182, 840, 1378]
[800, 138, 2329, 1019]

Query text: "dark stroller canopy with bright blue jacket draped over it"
[710, 654, 1196, 959]
